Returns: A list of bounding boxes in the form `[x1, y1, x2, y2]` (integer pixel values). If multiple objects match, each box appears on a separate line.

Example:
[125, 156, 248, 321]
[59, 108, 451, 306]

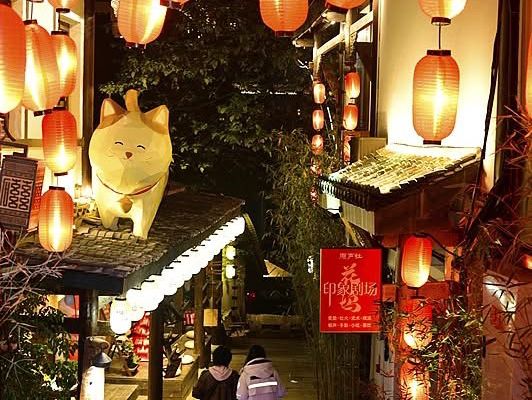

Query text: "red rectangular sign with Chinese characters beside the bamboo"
[320, 248, 382, 333]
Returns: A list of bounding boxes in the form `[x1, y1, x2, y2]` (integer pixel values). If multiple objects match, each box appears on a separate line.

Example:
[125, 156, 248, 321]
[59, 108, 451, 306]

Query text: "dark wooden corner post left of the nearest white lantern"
[78, 290, 98, 397]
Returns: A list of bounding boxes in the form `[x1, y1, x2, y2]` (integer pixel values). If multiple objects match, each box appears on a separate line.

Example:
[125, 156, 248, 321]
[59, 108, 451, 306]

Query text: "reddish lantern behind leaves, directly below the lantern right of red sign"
[403, 299, 432, 349]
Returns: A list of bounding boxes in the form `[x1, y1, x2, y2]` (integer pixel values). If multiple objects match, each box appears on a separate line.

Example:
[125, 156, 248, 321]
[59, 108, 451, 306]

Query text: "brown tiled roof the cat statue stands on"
[20, 192, 243, 294]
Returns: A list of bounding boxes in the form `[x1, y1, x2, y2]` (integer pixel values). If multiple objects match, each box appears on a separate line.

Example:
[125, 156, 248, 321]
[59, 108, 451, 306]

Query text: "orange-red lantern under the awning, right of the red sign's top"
[401, 236, 432, 288]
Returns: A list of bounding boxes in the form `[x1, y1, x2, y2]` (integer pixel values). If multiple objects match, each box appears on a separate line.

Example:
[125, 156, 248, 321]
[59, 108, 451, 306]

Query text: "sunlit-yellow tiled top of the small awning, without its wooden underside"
[320, 144, 479, 210]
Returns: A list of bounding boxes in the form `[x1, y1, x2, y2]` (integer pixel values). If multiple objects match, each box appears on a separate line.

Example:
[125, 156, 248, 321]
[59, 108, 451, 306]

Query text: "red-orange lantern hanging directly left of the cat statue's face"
[42, 107, 78, 175]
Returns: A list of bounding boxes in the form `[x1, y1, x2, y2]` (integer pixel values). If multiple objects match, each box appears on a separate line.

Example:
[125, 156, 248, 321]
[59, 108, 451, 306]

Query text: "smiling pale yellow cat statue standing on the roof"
[89, 90, 172, 239]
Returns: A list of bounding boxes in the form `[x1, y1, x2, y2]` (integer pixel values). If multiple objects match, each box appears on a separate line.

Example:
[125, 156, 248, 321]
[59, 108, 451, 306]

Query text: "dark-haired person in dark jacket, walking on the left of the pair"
[192, 346, 238, 400]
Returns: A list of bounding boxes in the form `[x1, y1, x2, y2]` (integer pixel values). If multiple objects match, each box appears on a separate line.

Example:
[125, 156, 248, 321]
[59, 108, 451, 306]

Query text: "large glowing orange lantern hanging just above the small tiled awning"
[412, 50, 460, 144]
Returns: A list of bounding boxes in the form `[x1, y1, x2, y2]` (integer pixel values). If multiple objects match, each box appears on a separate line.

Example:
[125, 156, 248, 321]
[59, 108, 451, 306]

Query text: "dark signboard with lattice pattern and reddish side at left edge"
[0, 143, 45, 231]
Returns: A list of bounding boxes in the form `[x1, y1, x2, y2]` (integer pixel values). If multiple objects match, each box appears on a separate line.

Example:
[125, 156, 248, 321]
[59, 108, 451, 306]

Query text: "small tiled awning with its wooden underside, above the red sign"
[319, 144, 480, 235]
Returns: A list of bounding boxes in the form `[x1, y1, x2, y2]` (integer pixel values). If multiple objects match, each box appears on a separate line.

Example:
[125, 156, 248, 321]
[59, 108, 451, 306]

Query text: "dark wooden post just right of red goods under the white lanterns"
[148, 307, 164, 400]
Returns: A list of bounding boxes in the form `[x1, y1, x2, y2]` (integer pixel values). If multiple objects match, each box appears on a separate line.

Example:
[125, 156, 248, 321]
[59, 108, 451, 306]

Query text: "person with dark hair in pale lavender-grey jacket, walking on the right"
[236, 345, 286, 400]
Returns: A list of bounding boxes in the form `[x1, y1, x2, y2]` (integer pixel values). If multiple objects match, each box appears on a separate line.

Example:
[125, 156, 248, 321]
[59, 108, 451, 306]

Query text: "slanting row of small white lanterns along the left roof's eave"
[110, 217, 246, 335]
